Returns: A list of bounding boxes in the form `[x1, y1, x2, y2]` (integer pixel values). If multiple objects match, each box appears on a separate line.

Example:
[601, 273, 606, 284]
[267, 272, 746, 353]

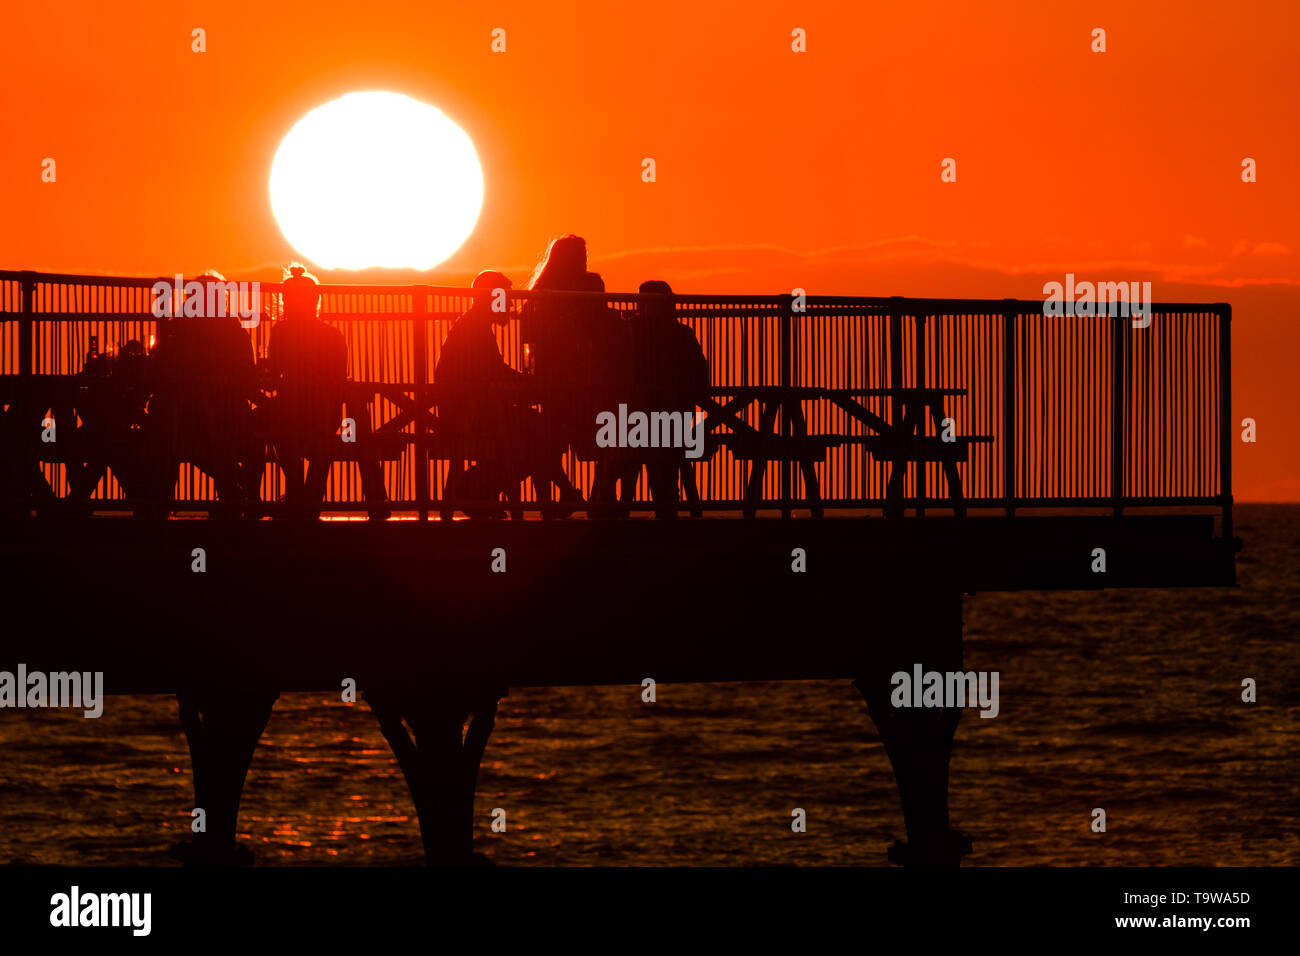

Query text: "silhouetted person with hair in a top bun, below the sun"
[265, 265, 390, 520]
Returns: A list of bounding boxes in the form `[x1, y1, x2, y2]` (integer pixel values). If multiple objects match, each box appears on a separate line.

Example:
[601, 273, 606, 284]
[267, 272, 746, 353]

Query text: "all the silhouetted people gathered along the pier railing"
[0, 235, 709, 520]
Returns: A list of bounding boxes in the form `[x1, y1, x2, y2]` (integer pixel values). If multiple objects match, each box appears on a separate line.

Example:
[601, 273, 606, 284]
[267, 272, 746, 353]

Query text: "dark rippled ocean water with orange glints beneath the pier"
[0, 505, 1300, 865]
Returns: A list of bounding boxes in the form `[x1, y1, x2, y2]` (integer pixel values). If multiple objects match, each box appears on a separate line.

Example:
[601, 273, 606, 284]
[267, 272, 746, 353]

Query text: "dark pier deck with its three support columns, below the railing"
[0, 515, 1235, 865]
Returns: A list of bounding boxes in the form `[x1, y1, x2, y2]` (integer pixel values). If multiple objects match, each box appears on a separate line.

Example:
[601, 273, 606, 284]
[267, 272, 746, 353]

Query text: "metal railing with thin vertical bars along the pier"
[0, 265, 1231, 533]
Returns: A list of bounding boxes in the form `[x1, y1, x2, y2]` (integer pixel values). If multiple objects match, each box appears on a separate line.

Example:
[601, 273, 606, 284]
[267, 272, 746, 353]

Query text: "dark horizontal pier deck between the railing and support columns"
[0, 514, 1235, 693]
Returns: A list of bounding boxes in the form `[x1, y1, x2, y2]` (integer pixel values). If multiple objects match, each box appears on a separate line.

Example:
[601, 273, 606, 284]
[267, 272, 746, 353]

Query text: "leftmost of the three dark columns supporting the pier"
[172, 688, 280, 866]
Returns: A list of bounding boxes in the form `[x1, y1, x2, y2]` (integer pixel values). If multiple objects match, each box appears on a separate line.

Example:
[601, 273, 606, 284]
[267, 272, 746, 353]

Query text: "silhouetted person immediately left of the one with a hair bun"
[148, 273, 260, 515]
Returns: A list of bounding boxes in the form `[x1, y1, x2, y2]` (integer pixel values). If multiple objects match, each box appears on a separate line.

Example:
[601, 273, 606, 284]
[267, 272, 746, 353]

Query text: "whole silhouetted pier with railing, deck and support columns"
[0, 272, 1238, 866]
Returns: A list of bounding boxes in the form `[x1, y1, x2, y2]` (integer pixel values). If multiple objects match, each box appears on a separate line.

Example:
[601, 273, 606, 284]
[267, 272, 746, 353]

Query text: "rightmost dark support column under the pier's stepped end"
[853, 591, 971, 866]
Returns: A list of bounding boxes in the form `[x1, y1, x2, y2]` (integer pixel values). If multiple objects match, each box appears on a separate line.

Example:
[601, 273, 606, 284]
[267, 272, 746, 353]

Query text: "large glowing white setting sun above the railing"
[270, 92, 484, 269]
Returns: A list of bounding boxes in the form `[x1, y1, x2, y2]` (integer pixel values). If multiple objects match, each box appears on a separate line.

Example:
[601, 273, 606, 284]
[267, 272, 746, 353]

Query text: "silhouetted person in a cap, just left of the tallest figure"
[434, 271, 543, 516]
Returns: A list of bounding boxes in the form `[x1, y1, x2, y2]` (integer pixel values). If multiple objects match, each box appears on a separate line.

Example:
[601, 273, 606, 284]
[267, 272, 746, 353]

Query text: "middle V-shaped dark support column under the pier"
[364, 687, 506, 866]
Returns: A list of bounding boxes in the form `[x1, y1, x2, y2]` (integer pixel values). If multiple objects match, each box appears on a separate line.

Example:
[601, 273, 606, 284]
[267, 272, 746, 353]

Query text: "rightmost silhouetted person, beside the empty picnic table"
[621, 280, 709, 518]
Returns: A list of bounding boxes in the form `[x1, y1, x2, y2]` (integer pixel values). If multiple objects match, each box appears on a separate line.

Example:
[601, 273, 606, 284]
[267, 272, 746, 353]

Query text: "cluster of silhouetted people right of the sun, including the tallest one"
[434, 235, 709, 518]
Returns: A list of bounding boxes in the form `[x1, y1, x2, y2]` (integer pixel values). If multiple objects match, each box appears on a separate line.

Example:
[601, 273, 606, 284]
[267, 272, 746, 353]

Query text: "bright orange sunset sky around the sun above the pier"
[0, 0, 1300, 501]
